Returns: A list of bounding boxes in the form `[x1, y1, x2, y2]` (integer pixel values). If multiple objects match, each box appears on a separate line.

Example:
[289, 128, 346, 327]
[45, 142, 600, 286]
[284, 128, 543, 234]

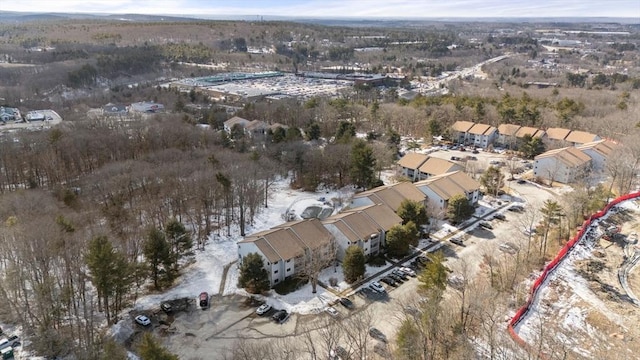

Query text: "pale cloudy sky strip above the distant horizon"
[0, 0, 640, 18]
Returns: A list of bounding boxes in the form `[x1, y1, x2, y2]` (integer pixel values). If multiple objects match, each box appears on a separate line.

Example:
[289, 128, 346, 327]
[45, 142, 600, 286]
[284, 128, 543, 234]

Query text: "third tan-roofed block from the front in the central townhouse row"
[349, 182, 427, 211]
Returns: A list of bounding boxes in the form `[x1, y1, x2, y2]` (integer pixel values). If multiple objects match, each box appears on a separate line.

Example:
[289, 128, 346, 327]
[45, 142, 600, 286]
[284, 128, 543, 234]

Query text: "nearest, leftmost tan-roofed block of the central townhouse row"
[238, 219, 336, 286]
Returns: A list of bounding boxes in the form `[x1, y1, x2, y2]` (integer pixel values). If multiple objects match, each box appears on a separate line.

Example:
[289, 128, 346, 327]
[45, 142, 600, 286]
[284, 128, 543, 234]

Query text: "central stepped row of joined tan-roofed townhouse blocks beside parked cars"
[238, 171, 480, 286]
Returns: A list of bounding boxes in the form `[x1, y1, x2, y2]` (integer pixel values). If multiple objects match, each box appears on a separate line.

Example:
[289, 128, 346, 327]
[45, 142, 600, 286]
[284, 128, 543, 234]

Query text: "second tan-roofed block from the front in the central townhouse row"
[322, 204, 402, 260]
